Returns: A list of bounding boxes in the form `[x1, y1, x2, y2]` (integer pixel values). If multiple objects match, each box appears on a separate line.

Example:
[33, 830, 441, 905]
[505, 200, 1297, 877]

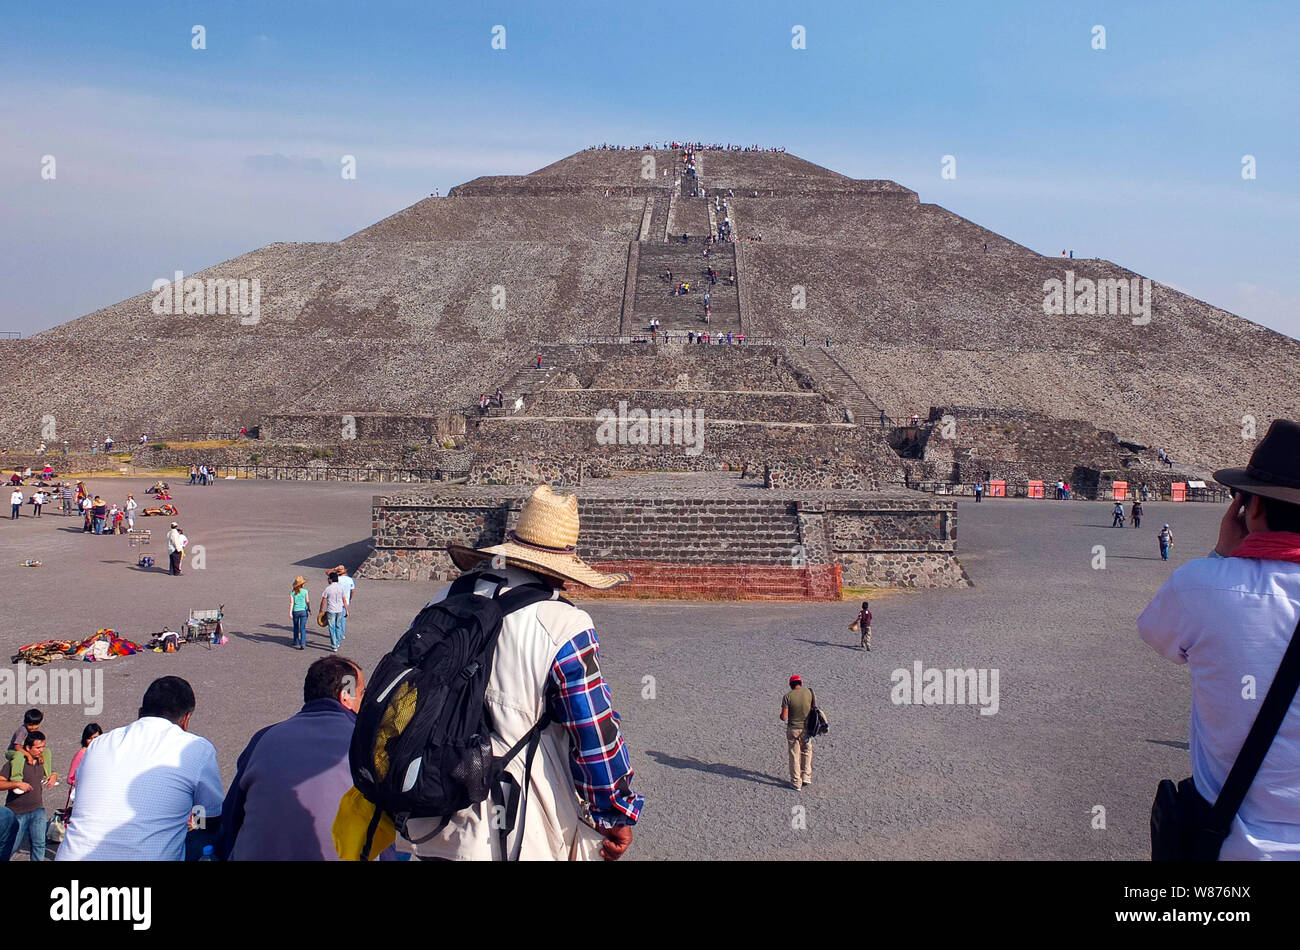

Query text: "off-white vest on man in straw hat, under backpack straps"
[398, 567, 605, 860]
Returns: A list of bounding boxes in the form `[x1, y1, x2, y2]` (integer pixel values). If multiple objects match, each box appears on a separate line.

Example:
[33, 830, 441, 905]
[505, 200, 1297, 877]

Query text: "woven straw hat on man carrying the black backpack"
[447, 485, 632, 590]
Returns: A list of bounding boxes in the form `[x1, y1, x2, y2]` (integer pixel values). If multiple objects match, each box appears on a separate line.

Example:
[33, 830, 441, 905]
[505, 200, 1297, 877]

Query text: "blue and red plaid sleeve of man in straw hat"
[547, 630, 645, 828]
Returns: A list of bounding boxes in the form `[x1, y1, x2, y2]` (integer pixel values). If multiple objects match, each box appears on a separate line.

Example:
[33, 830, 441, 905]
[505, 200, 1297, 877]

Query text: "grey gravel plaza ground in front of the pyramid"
[0, 478, 1222, 860]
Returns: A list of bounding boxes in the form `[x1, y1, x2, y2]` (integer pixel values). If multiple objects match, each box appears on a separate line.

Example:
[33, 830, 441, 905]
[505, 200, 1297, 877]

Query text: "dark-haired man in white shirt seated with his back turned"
[55, 676, 224, 860]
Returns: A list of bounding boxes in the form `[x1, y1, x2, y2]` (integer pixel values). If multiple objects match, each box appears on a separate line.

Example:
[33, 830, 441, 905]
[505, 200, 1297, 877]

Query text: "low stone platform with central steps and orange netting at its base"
[360, 473, 969, 599]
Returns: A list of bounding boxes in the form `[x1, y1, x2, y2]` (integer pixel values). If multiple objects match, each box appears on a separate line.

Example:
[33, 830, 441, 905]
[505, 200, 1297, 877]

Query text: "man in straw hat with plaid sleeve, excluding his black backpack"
[398, 485, 644, 860]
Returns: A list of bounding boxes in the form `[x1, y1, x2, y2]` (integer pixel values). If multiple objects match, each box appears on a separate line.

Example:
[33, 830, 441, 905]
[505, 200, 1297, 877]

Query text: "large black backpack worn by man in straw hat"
[348, 573, 568, 860]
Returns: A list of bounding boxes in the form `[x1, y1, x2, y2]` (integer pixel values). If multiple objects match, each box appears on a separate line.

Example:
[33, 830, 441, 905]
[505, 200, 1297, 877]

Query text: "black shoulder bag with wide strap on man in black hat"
[1151, 624, 1300, 860]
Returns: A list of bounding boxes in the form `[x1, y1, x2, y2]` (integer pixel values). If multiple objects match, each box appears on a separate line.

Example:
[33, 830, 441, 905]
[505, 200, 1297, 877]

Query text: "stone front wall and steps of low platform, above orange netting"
[360, 486, 969, 587]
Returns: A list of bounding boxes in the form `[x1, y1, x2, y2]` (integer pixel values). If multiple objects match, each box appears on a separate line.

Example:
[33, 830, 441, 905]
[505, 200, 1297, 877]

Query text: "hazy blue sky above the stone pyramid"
[0, 0, 1300, 338]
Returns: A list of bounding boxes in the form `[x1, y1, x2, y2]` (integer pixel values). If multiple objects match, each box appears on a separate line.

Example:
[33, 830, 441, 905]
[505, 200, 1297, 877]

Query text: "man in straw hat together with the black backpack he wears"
[334, 485, 644, 860]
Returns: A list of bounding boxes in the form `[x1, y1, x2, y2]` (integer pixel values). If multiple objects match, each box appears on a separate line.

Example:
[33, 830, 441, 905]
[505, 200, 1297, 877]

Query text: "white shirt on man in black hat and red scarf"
[1138, 556, 1300, 860]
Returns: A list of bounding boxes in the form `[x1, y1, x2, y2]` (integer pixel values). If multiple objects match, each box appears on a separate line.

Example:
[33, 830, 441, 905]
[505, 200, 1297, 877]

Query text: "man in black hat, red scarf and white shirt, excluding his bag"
[1138, 418, 1300, 860]
